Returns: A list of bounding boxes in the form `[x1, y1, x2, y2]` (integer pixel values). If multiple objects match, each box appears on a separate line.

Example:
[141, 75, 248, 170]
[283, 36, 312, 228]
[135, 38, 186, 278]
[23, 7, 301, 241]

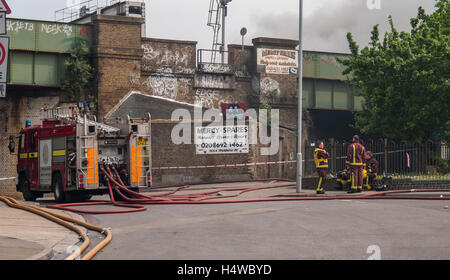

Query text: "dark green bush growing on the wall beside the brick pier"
[62, 39, 93, 101]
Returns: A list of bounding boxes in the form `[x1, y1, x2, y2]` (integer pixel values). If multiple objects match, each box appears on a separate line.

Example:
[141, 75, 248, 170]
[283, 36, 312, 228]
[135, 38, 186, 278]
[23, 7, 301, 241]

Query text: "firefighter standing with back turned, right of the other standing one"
[345, 135, 366, 193]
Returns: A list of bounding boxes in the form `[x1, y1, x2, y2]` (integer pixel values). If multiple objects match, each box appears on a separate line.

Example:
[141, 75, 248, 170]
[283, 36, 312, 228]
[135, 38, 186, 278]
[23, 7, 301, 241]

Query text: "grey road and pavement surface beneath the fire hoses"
[0, 182, 450, 260]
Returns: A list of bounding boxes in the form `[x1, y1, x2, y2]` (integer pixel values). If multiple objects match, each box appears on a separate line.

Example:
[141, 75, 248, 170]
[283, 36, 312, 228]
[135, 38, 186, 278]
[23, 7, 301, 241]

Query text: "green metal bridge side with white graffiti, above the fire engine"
[6, 19, 92, 86]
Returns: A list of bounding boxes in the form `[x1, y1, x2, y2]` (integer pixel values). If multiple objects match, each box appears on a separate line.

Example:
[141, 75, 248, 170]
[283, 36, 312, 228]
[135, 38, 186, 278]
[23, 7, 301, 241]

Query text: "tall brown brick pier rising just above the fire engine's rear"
[92, 15, 144, 119]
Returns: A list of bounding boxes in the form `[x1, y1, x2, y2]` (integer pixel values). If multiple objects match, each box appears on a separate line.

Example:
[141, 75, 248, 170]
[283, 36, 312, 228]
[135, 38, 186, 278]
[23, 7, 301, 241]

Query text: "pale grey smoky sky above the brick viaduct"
[7, 0, 435, 52]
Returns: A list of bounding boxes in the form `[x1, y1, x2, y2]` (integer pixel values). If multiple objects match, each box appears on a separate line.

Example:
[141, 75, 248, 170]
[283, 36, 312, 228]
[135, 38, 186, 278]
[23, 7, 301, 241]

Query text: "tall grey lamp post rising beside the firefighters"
[296, 0, 303, 193]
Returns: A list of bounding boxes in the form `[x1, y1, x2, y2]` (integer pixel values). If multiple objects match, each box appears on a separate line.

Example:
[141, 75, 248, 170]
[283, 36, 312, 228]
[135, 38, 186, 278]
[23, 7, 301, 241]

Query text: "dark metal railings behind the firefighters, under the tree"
[305, 139, 450, 181]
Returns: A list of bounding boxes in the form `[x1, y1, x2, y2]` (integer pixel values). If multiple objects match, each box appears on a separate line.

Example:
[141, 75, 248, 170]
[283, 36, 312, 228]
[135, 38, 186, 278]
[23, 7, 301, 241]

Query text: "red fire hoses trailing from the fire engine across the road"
[47, 165, 450, 214]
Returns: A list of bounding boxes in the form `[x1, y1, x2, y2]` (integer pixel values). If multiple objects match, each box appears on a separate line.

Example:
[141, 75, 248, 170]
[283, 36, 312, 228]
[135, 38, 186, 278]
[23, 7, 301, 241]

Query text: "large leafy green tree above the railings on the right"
[340, 0, 450, 143]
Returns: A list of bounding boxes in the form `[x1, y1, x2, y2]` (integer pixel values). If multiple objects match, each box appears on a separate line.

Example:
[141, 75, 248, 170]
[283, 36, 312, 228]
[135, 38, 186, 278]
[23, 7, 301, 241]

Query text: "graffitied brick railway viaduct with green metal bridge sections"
[0, 1, 360, 196]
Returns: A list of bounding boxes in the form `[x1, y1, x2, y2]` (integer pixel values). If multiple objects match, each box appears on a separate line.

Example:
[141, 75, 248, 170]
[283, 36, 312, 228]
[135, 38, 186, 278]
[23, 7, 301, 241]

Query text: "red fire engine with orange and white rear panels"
[10, 107, 152, 202]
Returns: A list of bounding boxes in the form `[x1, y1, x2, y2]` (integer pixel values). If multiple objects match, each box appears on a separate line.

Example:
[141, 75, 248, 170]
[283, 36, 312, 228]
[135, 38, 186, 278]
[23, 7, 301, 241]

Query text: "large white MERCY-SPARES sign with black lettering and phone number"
[195, 125, 249, 155]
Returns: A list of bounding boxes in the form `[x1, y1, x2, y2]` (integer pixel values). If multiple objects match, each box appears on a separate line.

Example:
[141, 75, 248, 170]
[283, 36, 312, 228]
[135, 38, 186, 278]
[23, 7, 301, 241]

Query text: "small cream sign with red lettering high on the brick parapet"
[257, 49, 298, 74]
